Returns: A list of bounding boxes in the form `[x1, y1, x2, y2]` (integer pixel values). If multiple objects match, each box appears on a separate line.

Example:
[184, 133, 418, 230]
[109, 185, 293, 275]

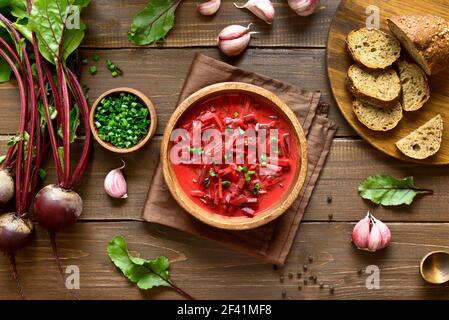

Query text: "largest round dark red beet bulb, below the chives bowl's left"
[32, 184, 83, 233]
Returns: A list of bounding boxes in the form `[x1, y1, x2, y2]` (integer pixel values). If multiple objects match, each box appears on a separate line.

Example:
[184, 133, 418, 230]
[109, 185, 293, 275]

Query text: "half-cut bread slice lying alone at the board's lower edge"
[396, 115, 443, 160]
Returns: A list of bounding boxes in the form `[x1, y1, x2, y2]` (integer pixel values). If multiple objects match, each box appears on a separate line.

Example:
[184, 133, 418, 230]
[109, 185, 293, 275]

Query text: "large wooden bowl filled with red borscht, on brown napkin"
[161, 82, 307, 230]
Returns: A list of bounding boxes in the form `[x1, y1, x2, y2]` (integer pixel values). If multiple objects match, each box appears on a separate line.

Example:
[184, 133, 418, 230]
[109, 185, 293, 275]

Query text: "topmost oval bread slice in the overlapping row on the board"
[346, 28, 401, 69]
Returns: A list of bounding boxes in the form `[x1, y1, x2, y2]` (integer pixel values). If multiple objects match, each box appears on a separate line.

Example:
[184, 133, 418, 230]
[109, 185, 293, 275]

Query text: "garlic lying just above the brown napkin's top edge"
[217, 23, 257, 57]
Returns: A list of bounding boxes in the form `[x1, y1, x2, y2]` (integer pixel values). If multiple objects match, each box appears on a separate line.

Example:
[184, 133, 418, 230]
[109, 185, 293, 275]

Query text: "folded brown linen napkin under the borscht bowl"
[142, 54, 337, 265]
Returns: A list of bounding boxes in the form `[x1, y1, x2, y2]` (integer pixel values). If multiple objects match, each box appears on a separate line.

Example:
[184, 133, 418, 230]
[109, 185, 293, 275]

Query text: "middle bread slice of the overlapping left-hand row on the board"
[347, 64, 401, 108]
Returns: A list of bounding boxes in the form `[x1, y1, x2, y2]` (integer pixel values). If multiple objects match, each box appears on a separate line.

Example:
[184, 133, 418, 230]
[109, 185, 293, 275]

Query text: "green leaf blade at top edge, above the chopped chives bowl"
[128, 0, 181, 45]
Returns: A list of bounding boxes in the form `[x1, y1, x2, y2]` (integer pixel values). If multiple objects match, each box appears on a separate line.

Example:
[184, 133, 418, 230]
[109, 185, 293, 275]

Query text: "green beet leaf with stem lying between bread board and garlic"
[359, 175, 433, 206]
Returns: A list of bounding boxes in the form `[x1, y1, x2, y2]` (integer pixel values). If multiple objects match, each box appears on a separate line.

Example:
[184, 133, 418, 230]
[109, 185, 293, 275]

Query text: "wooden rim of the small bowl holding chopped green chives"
[89, 87, 157, 153]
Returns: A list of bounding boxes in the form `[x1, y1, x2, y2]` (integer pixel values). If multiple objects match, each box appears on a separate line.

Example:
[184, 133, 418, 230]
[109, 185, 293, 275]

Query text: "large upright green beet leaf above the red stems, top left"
[29, 0, 90, 64]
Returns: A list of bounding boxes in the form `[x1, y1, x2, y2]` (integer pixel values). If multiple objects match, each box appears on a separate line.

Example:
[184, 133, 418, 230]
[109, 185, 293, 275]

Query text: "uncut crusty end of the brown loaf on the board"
[387, 14, 449, 75]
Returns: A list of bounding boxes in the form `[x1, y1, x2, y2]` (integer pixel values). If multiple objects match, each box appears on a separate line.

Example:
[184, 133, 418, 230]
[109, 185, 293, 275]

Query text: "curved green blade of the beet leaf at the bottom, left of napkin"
[107, 236, 170, 290]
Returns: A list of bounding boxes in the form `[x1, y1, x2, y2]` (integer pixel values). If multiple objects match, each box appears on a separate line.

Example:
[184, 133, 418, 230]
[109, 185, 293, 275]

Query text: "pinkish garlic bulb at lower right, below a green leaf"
[352, 212, 391, 251]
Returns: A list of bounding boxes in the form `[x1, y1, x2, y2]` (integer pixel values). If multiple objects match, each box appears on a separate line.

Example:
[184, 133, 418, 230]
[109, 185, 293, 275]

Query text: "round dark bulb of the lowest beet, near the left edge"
[0, 212, 34, 255]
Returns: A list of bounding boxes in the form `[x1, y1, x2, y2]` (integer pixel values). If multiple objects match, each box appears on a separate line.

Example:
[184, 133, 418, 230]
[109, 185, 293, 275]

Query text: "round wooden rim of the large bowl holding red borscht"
[161, 82, 307, 230]
